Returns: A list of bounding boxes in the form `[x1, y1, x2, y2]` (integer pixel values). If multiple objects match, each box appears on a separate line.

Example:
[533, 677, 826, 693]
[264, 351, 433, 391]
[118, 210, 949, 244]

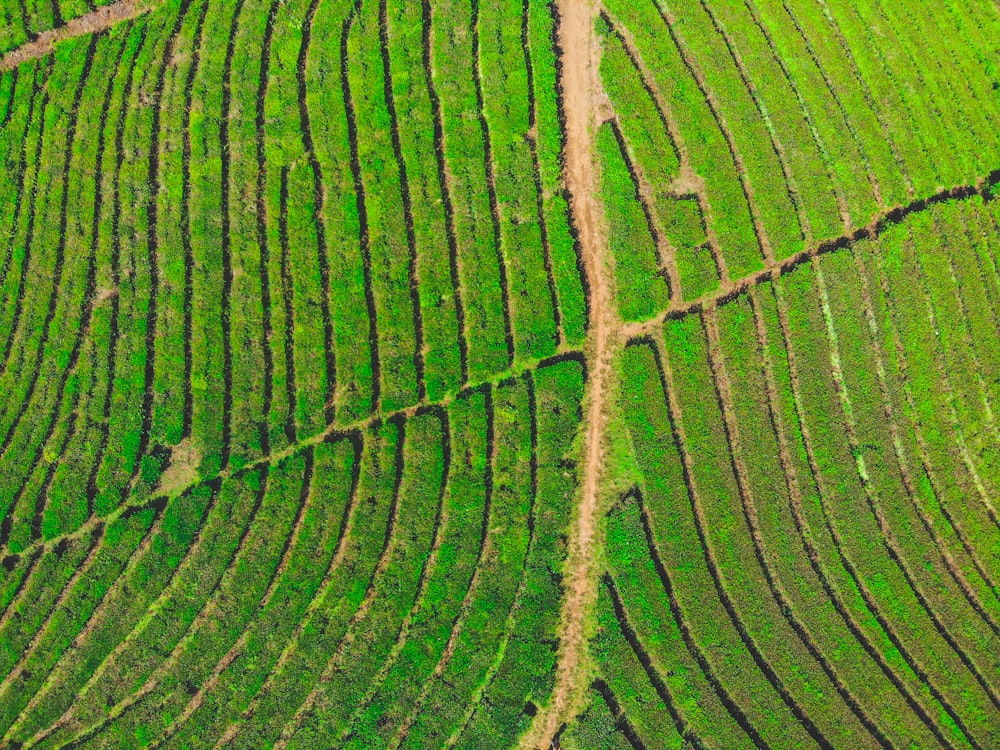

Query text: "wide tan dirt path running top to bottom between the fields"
[521, 0, 618, 748]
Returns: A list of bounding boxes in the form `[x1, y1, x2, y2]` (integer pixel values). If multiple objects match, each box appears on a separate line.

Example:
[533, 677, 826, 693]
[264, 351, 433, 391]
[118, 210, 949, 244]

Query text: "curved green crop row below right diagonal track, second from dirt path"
[664, 316, 867, 746]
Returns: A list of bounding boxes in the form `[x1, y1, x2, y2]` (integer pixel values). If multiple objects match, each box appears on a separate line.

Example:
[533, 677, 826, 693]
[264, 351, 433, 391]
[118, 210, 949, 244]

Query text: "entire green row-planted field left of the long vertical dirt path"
[0, 0, 586, 748]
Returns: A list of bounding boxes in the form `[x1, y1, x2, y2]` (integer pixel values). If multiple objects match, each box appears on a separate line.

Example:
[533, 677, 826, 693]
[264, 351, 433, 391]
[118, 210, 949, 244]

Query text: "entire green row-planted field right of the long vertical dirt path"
[584, 0, 1000, 748]
